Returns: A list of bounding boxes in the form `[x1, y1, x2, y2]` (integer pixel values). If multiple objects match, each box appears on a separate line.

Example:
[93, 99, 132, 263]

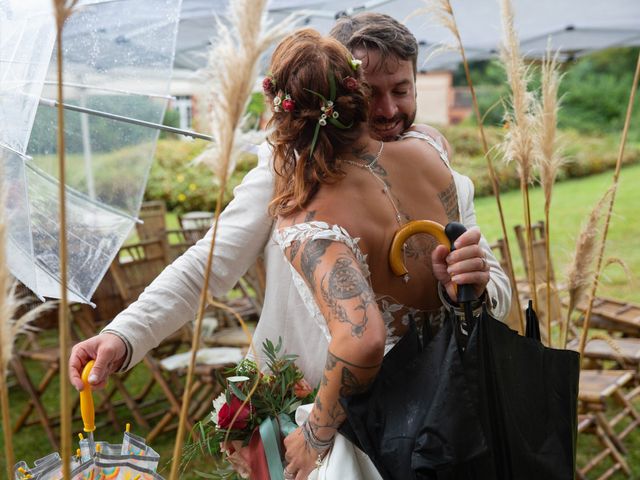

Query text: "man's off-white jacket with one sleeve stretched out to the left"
[103, 144, 511, 385]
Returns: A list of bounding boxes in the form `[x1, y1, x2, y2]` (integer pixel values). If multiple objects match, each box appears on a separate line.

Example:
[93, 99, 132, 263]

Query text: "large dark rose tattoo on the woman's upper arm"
[320, 257, 375, 337]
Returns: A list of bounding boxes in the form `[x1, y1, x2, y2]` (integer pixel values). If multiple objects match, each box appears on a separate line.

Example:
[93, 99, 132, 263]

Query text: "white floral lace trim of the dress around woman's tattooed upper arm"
[273, 221, 442, 354]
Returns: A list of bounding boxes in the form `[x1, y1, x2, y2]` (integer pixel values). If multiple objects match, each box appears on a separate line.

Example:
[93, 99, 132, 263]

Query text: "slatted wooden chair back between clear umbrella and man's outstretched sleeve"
[110, 240, 166, 305]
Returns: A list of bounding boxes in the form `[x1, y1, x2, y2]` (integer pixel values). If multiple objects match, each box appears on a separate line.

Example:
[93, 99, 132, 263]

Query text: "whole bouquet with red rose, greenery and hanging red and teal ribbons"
[183, 338, 317, 480]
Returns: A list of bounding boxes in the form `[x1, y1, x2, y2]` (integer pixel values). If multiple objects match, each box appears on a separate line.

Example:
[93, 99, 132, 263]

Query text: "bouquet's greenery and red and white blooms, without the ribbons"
[182, 338, 317, 480]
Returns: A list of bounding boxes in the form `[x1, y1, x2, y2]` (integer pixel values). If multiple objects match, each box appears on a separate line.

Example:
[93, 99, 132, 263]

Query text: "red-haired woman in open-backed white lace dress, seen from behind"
[263, 29, 498, 480]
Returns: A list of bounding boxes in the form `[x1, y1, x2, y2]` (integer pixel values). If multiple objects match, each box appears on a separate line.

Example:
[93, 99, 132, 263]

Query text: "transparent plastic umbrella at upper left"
[0, 0, 181, 303]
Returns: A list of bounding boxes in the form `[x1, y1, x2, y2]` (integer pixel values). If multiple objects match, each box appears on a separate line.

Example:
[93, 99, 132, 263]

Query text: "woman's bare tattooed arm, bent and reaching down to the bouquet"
[288, 239, 386, 446]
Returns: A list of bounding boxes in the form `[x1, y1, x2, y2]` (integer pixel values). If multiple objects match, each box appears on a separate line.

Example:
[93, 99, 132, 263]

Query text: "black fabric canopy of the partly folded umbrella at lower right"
[341, 221, 579, 480]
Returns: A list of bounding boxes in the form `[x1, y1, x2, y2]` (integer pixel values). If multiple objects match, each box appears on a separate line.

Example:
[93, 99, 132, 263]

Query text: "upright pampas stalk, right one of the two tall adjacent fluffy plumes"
[535, 46, 564, 345]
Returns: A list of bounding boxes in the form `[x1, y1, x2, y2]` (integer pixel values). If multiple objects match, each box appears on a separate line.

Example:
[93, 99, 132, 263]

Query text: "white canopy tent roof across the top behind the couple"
[175, 0, 640, 71]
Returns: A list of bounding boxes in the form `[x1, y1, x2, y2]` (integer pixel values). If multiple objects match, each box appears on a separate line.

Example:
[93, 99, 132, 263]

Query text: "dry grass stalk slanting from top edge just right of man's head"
[410, 0, 524, 333]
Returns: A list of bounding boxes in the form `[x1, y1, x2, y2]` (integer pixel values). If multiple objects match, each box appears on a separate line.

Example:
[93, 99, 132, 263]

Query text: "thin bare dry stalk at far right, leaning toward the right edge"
[579, 53, 640, 358]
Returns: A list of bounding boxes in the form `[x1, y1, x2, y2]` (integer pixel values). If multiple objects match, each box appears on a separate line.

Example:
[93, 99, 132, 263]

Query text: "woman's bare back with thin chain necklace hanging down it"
[280, 127, 459, 333]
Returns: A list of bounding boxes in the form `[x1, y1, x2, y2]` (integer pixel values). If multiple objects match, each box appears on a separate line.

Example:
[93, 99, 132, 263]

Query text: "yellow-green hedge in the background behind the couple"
[145, 125, 640, 212]
